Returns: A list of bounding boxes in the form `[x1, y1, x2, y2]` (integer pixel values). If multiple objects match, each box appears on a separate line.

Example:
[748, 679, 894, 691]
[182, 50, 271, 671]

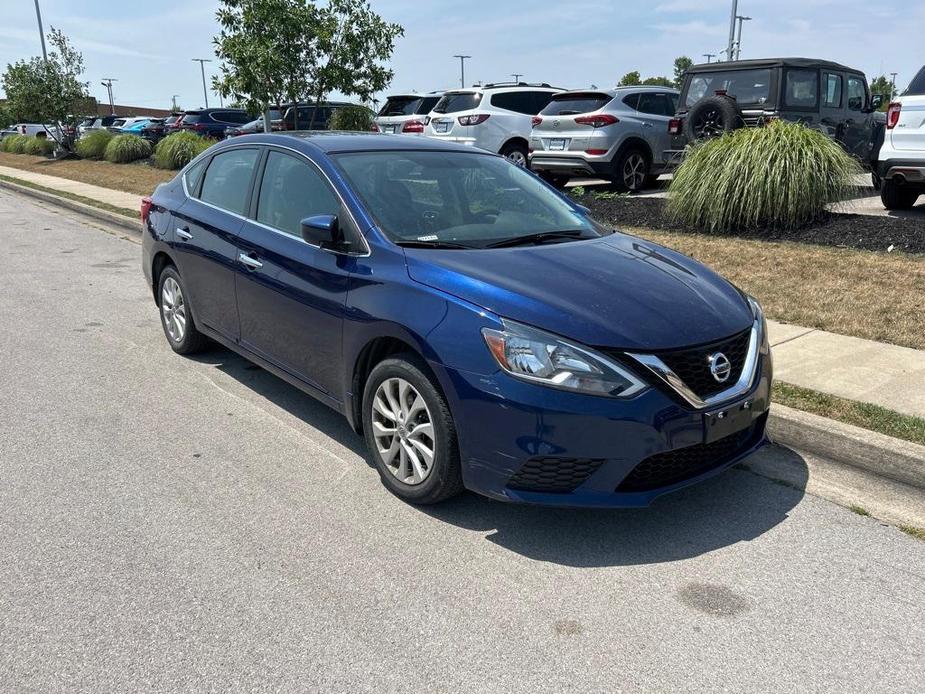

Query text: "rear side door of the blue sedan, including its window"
[171, 147, 260, 340]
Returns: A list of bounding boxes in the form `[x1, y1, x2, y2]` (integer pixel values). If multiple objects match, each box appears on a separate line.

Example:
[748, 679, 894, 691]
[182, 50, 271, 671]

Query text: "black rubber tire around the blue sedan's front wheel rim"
[363, 353, 463, 504]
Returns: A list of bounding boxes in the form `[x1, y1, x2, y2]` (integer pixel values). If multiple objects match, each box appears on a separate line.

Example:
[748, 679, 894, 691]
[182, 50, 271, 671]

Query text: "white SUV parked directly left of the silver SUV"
[424, 82, 564, 166]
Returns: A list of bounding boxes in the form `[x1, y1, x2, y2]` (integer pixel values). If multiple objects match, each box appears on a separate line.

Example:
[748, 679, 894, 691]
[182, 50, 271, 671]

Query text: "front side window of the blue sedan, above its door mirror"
[257, 151, 340, 238]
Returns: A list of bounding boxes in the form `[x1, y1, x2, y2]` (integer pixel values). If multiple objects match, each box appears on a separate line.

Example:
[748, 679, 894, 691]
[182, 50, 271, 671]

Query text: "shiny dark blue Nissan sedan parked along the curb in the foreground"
[142, 133, 771, 507]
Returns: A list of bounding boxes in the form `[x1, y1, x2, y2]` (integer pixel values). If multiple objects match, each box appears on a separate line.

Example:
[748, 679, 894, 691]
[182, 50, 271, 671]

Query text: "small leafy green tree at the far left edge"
[0, 27, 89, 147]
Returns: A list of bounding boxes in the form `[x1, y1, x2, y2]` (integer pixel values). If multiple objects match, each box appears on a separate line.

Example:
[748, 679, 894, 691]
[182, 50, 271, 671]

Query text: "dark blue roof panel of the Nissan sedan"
[219, 130, 490, 154]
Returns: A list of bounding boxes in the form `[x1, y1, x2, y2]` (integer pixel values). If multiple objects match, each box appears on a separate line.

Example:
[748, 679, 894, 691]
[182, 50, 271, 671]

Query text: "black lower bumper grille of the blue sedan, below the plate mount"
[617, 413, 768, 492]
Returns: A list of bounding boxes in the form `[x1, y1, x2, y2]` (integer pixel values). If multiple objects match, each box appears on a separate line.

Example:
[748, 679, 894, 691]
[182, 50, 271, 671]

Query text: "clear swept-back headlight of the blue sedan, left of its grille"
[482, 321, 646, 398]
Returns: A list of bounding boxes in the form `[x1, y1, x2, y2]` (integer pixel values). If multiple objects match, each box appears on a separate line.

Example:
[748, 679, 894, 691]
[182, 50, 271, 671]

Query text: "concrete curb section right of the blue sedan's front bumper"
[768, 404, 925, 489]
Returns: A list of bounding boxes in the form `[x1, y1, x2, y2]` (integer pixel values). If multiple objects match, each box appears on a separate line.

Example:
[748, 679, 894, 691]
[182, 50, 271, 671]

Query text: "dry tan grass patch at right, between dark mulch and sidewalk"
[627, 229, 925, 349]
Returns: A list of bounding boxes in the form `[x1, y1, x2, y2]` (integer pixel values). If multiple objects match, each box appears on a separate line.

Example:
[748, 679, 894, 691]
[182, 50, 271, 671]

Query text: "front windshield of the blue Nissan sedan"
[334, 151, 610, 248]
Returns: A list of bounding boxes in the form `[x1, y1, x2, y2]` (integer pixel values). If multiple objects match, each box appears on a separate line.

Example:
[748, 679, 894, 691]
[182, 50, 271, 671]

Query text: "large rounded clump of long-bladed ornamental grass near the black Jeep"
[667, 121, 861, 231]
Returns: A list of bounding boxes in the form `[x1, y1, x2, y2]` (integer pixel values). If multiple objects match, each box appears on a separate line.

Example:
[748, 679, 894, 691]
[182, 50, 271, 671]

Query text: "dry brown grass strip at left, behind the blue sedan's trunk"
[0, 152, 176, 195]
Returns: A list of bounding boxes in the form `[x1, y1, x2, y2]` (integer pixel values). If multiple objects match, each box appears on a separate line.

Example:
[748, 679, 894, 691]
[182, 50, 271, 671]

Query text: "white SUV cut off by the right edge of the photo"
[877, 67, 925, 210]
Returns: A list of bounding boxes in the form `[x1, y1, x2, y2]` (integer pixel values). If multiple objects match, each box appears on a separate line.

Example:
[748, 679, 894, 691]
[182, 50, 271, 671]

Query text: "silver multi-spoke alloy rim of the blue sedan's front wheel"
[372, 378, 437, 485]
